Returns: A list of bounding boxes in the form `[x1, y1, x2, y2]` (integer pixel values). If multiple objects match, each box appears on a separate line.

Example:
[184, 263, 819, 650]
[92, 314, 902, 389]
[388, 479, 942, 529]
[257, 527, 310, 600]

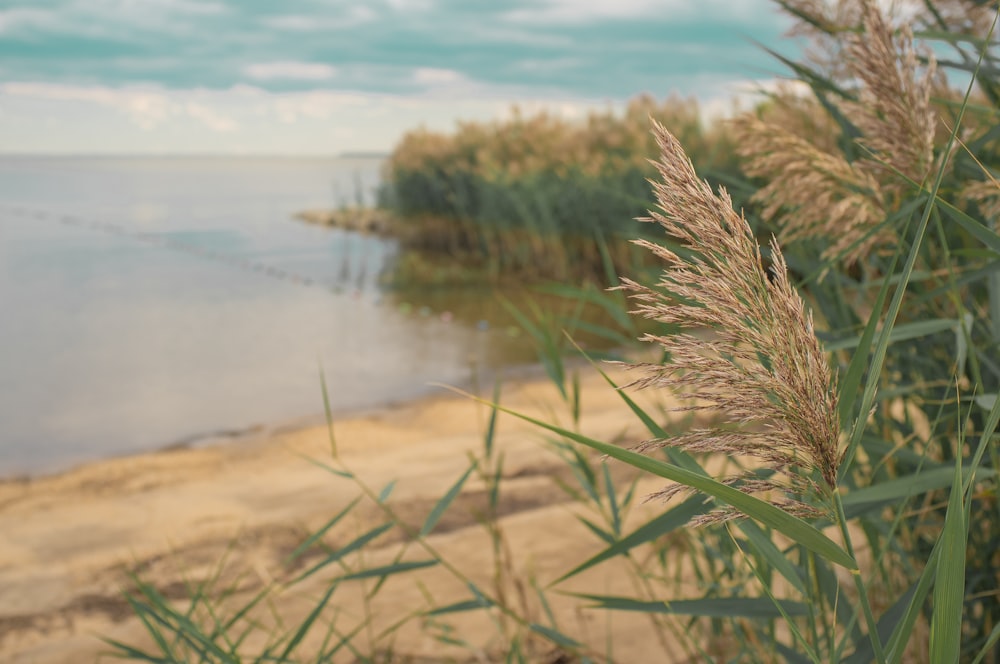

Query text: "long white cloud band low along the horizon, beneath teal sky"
[0, 79, 624, 155]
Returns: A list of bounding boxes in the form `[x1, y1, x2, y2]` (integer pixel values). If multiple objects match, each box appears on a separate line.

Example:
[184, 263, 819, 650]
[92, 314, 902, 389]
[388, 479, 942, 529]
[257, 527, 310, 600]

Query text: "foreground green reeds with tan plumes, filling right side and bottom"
[107, 0, 1000, 664]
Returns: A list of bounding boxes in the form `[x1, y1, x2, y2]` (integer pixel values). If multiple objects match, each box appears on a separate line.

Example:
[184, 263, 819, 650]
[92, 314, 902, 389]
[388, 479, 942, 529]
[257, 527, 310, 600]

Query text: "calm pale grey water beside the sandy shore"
[0, 157, 500, 477]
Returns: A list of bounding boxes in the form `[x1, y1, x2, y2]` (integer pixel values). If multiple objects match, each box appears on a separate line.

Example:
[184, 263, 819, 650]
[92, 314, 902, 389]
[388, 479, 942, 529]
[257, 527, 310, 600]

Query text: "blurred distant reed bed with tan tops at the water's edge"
[380, 96, 736, 281]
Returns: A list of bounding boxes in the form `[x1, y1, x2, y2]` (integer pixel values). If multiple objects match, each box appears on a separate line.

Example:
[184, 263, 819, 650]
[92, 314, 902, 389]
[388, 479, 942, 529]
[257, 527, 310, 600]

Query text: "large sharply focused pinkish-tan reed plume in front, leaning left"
[621, 122, 840, 522]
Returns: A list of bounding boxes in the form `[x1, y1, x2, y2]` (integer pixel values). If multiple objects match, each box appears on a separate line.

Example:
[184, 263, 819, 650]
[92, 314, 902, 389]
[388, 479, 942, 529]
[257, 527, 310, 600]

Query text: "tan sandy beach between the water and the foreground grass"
[0, 368, 696, 663]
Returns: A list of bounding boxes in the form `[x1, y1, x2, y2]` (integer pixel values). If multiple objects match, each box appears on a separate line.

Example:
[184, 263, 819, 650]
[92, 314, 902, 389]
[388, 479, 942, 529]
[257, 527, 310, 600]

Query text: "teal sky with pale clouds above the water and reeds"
[0, 0, 790, 155]
